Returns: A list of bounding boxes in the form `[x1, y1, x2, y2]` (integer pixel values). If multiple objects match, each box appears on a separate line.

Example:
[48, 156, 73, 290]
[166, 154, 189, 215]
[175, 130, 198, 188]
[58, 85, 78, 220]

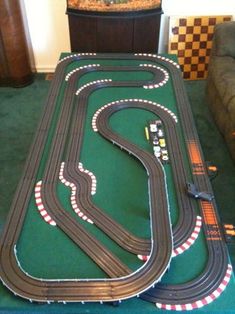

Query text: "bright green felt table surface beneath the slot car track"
[0, 54, 235, 313]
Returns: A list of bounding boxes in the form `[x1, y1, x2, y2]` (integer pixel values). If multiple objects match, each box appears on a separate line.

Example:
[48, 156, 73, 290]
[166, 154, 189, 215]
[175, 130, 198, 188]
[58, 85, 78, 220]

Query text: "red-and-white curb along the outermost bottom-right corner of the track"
[156, 264, 232, 311]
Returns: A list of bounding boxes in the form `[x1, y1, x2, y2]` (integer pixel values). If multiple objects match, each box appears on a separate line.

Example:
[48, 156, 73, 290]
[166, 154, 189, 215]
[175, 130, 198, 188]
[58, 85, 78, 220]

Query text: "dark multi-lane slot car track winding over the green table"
[0, 54, 231, 307]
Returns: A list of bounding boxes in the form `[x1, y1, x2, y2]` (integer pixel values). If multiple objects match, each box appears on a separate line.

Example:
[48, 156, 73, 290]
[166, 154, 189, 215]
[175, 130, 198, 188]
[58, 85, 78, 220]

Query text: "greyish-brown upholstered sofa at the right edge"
[207, 21, 235, 161]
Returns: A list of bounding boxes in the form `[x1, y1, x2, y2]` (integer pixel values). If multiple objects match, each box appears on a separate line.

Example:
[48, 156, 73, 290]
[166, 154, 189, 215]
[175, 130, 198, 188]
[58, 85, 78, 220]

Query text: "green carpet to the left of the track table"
[0, 74, 50, 231]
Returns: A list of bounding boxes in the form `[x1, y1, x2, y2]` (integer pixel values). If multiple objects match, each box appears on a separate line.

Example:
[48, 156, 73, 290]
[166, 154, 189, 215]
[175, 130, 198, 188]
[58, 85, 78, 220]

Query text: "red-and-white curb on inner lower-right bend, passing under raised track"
[137, 216, 202, 262]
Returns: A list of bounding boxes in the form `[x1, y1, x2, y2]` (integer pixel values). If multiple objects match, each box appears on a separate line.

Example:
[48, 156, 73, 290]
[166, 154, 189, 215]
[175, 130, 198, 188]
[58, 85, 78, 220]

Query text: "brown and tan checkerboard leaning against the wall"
[168, 15, 232, 80]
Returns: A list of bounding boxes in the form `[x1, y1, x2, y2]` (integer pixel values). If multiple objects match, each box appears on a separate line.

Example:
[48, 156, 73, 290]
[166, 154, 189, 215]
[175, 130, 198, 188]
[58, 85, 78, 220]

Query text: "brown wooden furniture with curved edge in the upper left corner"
[0, 0, 33, 87]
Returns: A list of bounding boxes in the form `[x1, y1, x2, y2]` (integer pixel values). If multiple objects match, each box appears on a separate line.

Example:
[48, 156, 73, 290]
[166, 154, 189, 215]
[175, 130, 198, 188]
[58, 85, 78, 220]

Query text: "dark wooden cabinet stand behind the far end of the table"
[67, 9, 162, 53]
